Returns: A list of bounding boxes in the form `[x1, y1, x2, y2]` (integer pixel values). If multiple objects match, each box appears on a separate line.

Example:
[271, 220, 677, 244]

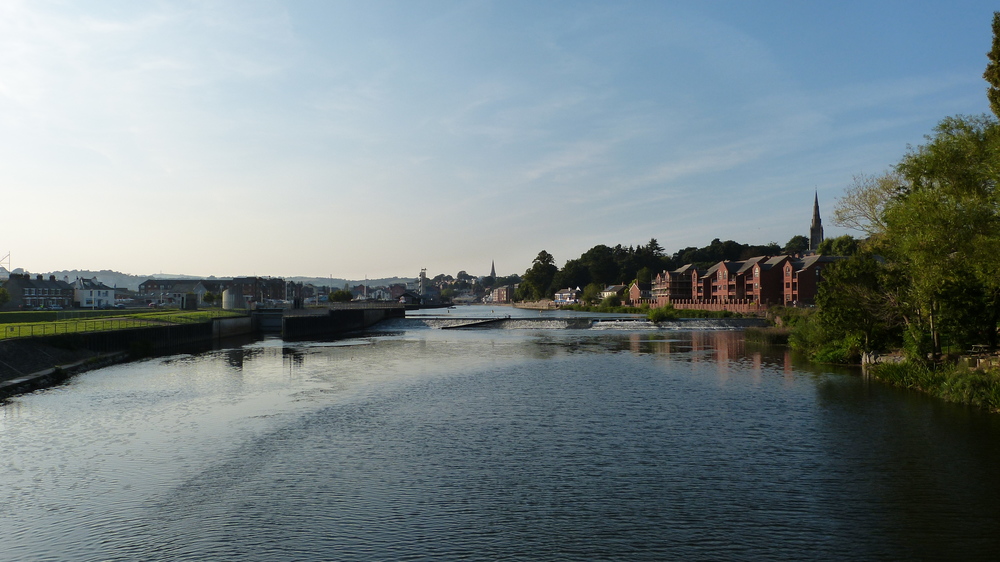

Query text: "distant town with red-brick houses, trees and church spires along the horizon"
[0, 197, 841, 312]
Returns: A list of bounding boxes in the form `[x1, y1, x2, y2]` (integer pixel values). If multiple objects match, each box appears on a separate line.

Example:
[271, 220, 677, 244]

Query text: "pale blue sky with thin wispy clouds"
[0, 0, 997, 279]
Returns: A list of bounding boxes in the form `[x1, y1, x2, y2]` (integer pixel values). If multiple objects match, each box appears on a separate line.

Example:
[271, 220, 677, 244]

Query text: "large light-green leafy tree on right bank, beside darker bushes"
[878, 115, 1000, 356]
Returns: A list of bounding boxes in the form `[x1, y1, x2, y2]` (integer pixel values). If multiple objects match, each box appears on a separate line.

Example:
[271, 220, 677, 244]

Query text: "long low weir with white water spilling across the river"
[378, 316, 767, 330]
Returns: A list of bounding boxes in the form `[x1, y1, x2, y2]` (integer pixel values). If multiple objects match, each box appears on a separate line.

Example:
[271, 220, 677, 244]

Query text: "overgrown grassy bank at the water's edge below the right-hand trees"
[869, 363, 1000, 412]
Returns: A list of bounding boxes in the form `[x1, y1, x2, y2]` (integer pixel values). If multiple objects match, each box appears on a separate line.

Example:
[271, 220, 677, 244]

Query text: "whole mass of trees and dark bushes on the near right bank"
[828, 105, 1000, 362]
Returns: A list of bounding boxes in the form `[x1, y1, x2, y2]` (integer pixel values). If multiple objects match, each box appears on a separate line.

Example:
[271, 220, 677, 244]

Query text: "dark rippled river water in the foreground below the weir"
[0, 309, 1000, 560]
